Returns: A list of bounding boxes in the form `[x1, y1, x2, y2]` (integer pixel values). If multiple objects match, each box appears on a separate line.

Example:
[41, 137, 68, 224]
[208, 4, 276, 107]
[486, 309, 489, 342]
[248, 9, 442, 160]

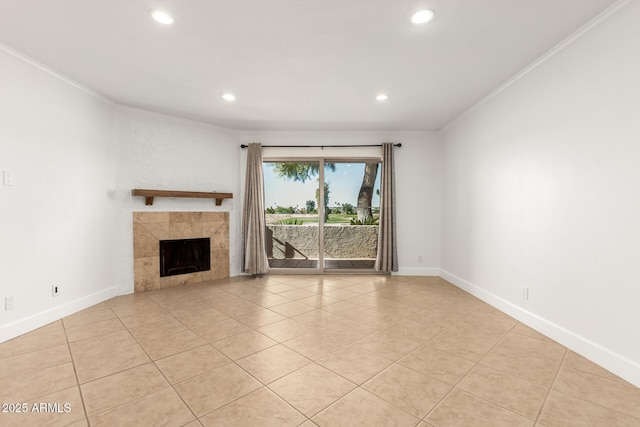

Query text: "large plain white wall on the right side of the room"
[443, 2, 640, 386]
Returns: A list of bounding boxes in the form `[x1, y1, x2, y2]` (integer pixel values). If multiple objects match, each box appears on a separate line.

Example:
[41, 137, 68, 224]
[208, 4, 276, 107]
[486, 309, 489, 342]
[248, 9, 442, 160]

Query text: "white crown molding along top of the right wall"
[438, 0, 640, 132]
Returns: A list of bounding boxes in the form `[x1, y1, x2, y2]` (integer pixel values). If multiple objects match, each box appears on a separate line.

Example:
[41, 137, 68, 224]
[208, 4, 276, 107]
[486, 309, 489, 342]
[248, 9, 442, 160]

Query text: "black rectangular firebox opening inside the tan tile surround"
[160, 237, 211, 277]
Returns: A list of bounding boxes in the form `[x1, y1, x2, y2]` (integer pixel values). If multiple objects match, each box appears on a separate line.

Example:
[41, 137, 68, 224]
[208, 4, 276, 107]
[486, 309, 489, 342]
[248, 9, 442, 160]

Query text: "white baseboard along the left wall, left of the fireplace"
[0, 286, 118, 343]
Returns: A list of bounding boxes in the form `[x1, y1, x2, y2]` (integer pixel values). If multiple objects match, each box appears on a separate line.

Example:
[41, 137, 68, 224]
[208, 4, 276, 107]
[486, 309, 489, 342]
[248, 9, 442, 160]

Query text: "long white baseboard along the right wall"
[440, 270, 640, 387]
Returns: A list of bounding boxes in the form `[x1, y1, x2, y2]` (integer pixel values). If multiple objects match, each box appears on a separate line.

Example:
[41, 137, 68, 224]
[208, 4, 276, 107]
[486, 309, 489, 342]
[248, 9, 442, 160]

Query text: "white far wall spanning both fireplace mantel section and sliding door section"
[116, 121, 443, 293]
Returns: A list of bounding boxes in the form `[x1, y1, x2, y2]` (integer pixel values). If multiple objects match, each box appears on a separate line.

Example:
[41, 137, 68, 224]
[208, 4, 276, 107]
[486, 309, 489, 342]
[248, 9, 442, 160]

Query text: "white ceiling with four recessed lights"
[0, 0, 615, 130]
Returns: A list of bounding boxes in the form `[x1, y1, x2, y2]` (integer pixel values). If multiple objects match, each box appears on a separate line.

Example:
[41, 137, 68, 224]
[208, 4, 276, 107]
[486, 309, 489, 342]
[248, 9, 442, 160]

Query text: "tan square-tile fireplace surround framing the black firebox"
[133, 212, 229, 292]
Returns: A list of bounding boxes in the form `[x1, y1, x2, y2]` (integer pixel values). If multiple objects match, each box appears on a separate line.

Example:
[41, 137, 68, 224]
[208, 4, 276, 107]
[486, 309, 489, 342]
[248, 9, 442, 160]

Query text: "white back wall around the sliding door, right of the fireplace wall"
[240, 131, 444, 275]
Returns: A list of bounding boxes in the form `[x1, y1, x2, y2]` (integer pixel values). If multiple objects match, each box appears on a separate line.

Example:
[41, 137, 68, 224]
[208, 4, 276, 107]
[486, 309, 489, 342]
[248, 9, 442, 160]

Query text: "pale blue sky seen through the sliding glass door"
[264, 163, 380, 208]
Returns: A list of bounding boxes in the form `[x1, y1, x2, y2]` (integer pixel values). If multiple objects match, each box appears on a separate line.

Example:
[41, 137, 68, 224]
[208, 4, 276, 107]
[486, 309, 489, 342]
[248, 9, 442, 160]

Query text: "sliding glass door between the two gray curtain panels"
[264, 159, 380, 272]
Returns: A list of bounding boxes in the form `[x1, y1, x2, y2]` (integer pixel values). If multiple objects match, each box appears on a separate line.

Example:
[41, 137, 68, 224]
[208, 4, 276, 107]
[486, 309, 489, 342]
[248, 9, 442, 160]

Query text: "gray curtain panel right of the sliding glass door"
[375, 143, 398, 273]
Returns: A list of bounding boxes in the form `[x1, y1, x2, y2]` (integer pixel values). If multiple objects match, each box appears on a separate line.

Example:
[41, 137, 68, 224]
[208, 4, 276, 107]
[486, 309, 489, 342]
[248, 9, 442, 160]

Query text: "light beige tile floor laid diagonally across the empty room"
[0, 275, 640, 427]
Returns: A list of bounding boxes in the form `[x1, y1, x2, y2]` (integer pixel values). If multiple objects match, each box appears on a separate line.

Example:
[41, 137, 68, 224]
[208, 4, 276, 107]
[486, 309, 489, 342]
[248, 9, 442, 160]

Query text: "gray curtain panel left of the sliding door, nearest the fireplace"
[242, 144, 269, 274]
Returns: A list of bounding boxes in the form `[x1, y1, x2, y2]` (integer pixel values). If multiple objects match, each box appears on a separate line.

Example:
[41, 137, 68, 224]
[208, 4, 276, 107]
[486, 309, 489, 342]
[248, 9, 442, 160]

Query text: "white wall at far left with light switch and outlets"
[0, 46, 116, 342]
